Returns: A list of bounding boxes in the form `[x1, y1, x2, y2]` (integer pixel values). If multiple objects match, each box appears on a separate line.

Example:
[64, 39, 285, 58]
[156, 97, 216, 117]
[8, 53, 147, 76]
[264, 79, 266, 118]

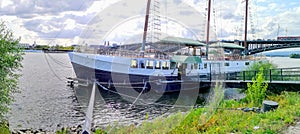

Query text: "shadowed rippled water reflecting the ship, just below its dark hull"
[74, 86, 203, 127]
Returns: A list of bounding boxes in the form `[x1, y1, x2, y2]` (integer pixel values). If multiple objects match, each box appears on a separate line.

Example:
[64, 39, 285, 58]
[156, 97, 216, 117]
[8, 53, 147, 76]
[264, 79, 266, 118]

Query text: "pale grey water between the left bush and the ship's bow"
[9, 53, 83, 130]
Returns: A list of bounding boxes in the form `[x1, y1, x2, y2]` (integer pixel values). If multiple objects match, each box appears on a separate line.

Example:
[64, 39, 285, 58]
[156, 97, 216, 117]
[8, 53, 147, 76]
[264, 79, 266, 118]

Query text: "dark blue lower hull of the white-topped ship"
[72, 62, 199, 92]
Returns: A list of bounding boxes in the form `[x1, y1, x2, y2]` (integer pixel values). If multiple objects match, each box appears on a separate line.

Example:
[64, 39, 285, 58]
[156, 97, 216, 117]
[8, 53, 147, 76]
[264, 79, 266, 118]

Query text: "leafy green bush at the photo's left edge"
[0, 22, 24, 122]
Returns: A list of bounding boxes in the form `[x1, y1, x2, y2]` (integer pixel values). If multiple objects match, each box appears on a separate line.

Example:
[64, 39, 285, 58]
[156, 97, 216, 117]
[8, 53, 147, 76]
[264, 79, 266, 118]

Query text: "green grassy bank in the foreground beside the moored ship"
[102, 92, 300, 134]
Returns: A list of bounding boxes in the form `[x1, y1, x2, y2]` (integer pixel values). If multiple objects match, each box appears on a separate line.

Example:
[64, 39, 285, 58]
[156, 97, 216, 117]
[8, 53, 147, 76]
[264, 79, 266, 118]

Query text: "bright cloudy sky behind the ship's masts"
[0, 0, 300, 46]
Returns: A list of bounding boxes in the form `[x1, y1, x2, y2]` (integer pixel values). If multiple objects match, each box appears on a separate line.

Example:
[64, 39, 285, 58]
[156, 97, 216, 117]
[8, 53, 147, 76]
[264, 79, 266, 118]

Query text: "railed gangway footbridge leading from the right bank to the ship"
[200, 67, 300, 92]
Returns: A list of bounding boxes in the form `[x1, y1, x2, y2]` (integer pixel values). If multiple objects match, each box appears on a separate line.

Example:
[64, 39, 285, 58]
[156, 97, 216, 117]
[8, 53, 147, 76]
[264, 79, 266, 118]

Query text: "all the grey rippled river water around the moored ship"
[8, 53, 300, 131]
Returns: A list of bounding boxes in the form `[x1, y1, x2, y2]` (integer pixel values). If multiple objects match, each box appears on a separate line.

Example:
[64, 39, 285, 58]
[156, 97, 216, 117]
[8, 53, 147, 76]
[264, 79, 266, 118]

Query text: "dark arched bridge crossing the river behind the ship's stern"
[224, 40, 300, 55]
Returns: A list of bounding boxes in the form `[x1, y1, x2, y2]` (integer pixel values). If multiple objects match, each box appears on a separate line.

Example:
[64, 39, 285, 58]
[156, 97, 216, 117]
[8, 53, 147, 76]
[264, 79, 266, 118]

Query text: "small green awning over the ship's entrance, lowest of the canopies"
[171, 55, 202, 63]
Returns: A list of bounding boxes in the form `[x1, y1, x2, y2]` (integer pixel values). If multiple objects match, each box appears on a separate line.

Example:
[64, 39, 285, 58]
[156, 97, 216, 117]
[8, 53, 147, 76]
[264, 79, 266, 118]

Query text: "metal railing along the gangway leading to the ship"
[225, 67, 300, 82]
